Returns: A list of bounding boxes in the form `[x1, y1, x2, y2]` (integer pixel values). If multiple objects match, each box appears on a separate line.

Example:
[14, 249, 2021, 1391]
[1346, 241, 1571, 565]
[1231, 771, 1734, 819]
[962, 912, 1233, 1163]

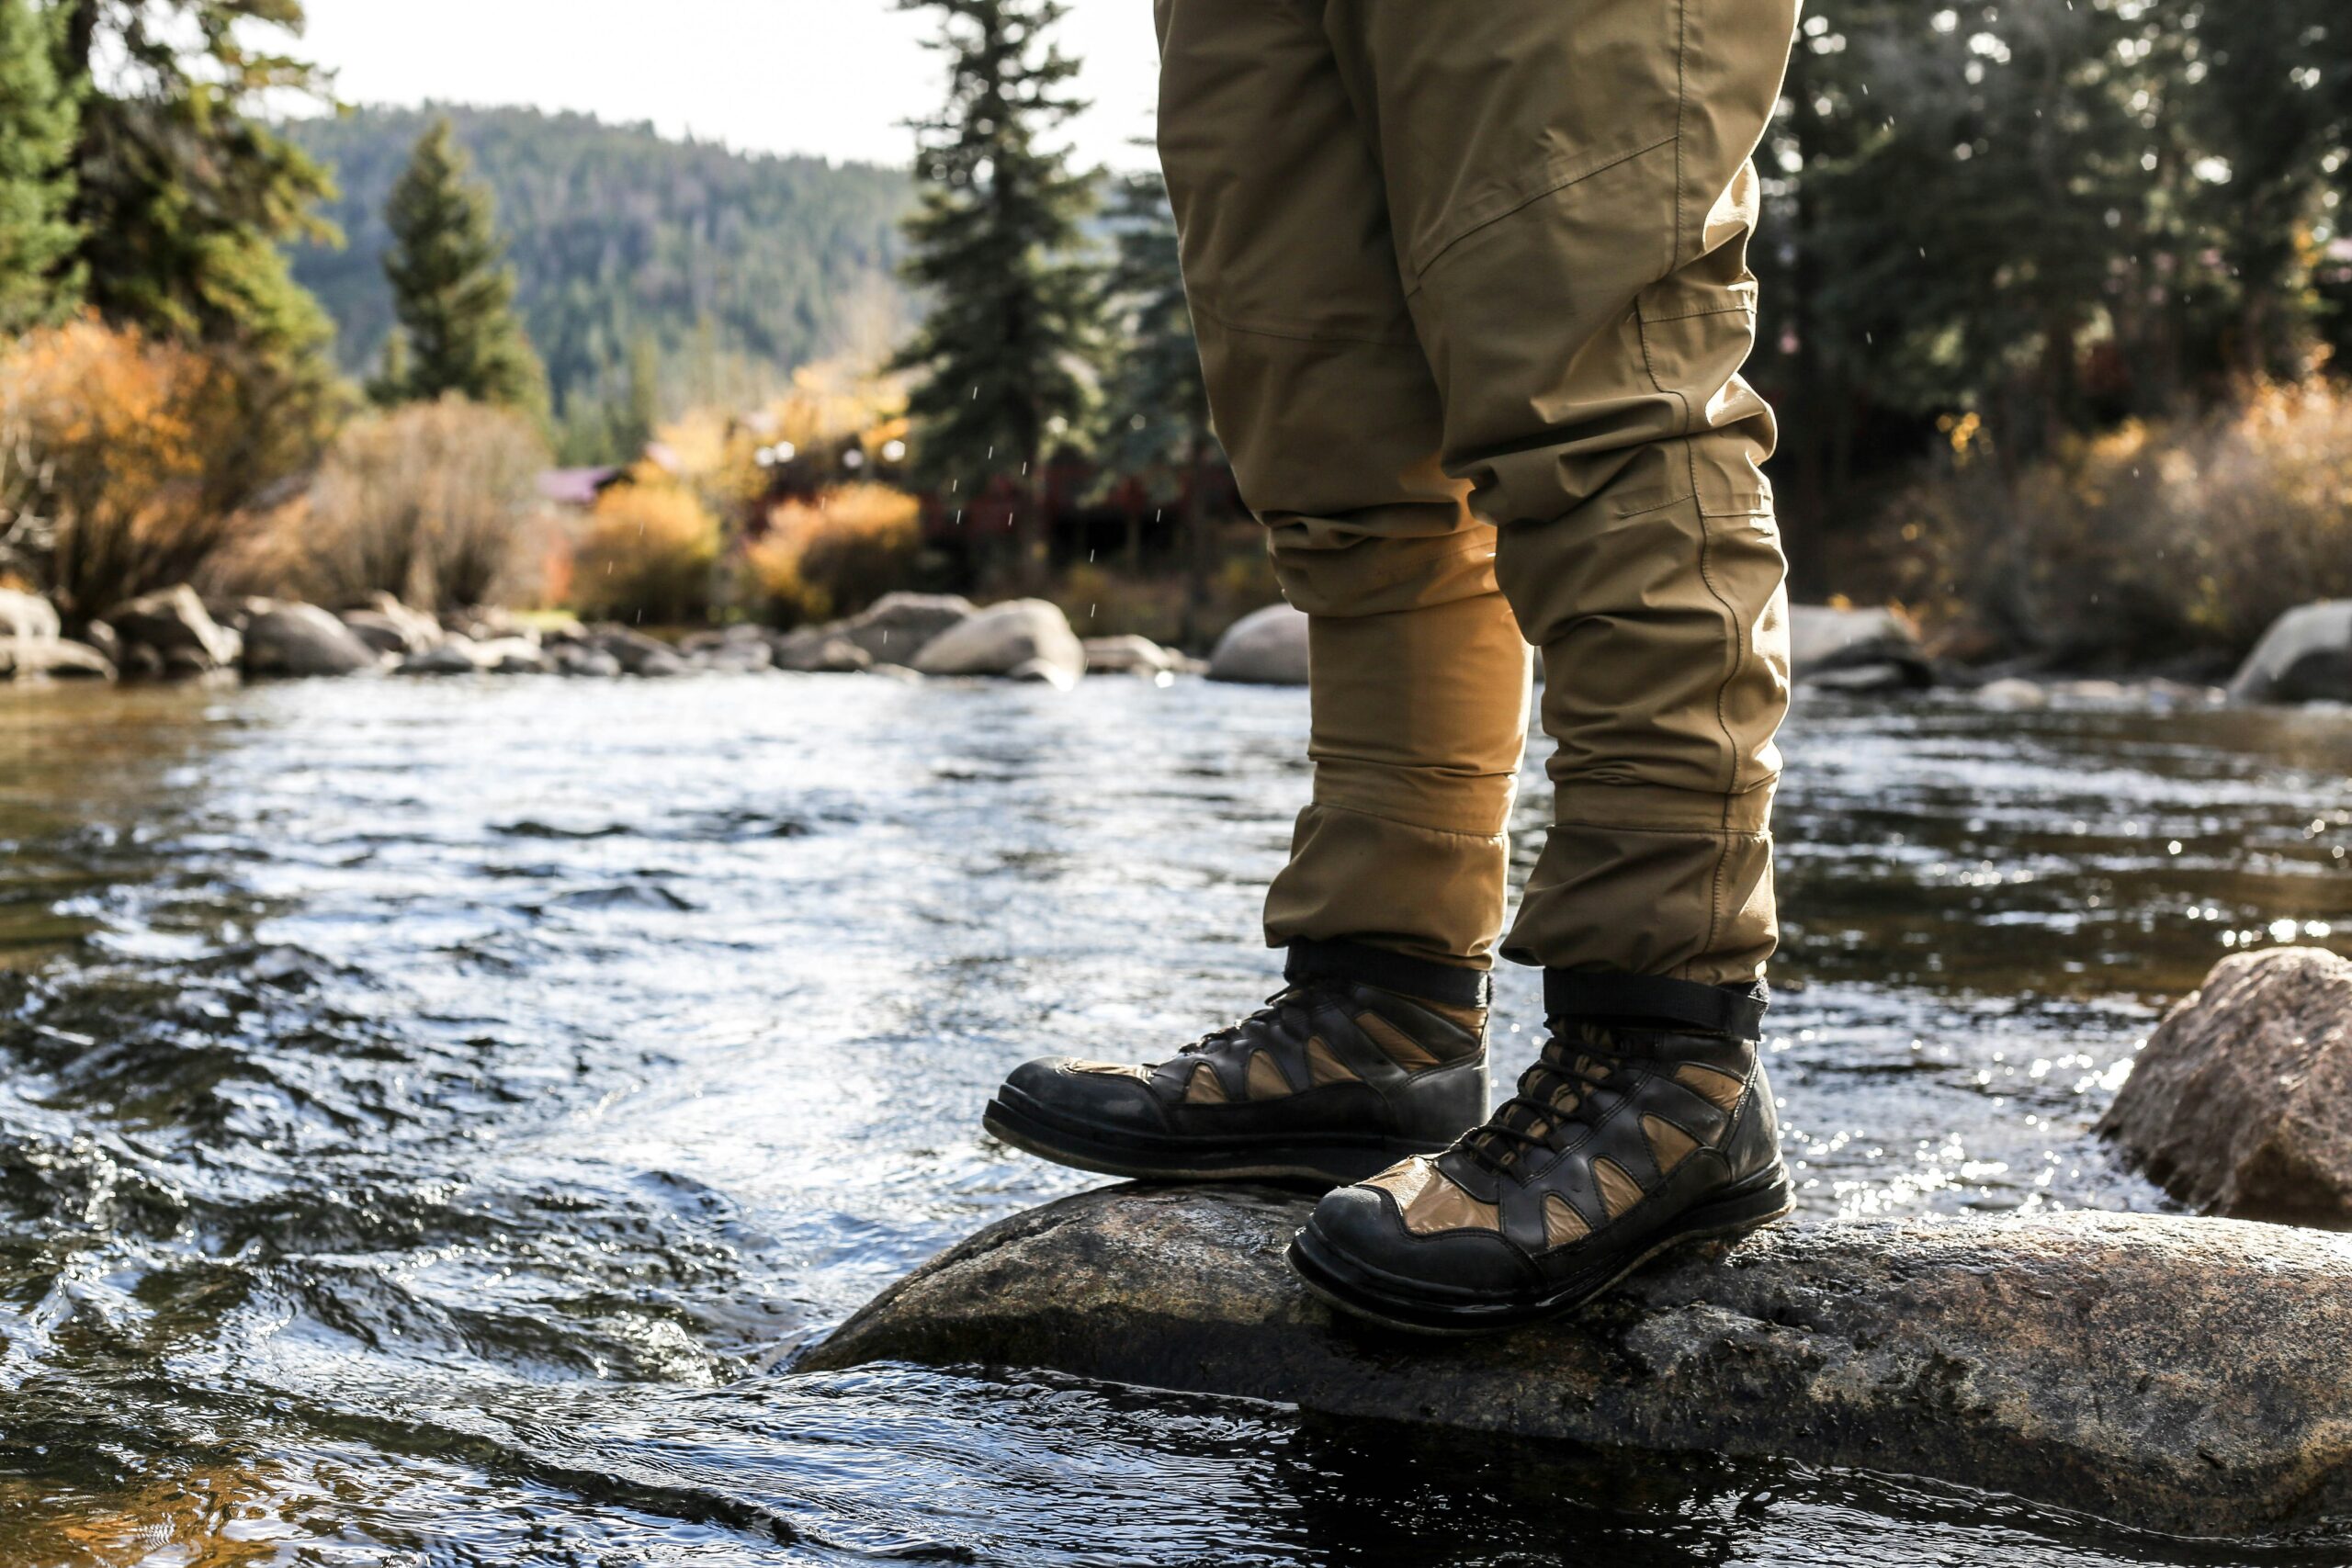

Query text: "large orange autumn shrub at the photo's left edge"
[0, 317, 299, 626]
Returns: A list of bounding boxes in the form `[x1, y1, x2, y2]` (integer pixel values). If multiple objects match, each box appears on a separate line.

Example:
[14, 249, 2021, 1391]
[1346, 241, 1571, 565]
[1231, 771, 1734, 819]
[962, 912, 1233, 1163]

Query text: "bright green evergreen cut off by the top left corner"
[0, 0, 80, 332]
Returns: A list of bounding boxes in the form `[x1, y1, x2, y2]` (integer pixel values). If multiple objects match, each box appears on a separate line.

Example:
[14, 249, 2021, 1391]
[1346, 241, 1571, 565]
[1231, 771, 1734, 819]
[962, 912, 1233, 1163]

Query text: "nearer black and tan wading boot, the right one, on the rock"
[1289, 968, 1790, 1333]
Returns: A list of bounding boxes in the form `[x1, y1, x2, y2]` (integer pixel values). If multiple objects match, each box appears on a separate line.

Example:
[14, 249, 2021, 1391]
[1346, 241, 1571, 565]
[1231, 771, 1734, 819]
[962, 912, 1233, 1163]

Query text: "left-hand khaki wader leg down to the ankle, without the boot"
[1158, 0, 1529, 968]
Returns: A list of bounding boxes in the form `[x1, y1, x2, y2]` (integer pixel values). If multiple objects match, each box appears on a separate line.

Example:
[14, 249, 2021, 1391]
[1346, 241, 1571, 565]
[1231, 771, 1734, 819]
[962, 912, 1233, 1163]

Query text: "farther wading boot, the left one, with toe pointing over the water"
[981, 941, 1487, 1187]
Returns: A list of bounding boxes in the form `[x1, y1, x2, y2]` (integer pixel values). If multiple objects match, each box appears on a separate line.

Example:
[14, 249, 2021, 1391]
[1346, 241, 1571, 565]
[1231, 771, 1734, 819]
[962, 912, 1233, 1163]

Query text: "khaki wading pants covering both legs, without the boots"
[1158, 0, 1797, 983]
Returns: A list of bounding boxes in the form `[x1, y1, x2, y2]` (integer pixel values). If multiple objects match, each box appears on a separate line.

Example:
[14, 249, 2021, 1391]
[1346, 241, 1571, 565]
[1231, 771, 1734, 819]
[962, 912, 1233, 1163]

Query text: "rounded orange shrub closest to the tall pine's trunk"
[743, 484, 922, 626]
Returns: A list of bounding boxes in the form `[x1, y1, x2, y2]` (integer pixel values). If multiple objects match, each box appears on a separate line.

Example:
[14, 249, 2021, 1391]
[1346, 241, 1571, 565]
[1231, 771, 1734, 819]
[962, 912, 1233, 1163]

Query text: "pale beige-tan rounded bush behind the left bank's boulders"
[279, 398, 548, 609]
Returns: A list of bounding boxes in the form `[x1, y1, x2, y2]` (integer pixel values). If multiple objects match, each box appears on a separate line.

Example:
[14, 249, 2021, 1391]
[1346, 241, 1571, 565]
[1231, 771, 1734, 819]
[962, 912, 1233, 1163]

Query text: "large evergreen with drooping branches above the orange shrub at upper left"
[51, 0, 344, 495]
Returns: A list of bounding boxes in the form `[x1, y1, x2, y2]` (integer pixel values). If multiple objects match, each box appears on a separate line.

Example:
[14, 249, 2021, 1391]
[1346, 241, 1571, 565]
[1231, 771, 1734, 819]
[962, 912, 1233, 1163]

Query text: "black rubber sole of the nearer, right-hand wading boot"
[1286, 1166, 1797, 1336]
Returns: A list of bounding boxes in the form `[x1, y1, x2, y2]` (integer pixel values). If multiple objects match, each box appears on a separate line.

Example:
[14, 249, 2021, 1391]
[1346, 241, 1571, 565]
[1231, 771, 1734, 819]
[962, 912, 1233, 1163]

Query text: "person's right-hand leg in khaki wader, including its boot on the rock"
[1301, 0, 1797, 1325]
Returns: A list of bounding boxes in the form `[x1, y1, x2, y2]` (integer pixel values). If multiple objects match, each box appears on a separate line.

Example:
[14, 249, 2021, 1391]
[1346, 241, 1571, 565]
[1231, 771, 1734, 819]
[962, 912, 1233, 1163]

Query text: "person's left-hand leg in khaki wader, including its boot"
[986, 0, 1529, 1180]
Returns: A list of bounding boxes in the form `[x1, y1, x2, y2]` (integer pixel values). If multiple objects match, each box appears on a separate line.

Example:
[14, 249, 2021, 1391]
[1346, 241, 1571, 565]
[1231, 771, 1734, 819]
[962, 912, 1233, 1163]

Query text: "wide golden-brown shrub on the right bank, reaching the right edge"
[1889, 381, 2352, 660]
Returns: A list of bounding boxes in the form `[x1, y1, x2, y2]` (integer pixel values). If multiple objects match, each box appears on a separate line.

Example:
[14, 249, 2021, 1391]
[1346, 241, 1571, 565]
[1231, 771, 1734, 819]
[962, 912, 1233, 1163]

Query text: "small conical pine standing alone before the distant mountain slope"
[383, 118, 548, 413]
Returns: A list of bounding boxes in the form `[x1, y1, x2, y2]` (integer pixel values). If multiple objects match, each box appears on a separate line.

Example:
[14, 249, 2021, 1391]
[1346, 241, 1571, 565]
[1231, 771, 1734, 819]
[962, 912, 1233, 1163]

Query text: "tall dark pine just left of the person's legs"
[896, 0, 1101, 581]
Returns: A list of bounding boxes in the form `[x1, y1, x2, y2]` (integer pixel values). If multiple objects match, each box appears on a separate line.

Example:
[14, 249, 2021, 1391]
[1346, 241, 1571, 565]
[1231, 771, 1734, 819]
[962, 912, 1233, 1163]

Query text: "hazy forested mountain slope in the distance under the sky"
[287, 108, 912, 419]
